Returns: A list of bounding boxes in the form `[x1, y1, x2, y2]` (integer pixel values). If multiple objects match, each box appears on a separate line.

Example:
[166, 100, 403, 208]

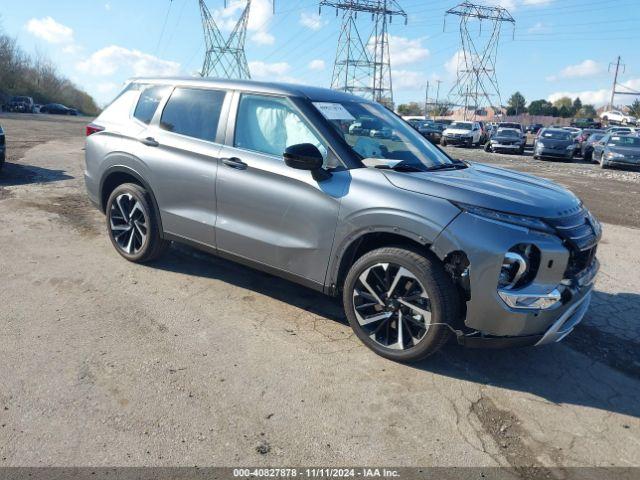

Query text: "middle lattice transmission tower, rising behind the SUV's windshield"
[320, 0, 407, 106]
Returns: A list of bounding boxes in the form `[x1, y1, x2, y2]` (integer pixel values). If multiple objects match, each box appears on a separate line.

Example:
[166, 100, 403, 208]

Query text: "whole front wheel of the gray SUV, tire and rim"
[343, 247, 460, 362]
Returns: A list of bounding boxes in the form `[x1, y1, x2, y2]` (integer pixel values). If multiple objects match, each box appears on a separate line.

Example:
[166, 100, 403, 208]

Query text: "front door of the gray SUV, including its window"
[216, 94, 350, 284]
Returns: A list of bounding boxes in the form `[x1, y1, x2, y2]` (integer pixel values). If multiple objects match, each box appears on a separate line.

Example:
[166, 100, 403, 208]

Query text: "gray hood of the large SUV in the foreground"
[383, 163, 581, 218]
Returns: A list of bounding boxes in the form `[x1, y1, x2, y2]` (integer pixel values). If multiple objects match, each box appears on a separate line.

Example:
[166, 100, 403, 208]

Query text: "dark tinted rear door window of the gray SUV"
[160, 87, 226, 142]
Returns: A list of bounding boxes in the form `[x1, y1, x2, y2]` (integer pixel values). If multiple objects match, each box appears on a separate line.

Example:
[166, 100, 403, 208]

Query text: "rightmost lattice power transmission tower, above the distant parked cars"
[445, 2, 515, 120]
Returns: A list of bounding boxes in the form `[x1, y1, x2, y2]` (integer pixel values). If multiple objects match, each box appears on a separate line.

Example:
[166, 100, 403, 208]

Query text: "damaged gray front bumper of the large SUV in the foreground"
[432, 212, 599, 347]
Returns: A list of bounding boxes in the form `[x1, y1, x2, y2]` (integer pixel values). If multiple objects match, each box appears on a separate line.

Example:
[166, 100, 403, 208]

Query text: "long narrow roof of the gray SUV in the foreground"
[129, 77, 367, 102]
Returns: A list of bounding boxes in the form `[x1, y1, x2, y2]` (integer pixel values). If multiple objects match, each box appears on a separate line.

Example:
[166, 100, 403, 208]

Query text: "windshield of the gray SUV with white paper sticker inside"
[313, 101, 453, 170]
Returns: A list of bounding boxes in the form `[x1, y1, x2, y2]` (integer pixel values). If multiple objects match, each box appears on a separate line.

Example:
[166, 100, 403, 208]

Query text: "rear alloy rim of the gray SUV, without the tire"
[109, 193, 148, 255]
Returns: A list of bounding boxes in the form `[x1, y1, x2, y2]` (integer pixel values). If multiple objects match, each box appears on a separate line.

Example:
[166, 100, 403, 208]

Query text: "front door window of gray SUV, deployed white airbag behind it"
[233, 94, 327, 160]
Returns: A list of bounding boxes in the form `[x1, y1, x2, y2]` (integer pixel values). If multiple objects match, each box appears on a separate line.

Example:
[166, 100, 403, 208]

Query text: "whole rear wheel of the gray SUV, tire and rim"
[106, 183, 168, 263]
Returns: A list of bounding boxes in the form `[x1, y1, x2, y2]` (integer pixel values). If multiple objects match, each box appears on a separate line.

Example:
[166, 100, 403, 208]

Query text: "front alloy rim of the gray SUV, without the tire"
[353, 263, 431, 350]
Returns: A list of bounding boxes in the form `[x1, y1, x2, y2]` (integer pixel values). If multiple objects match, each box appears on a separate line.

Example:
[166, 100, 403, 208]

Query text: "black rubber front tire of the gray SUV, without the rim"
[343, 247, 460, 362]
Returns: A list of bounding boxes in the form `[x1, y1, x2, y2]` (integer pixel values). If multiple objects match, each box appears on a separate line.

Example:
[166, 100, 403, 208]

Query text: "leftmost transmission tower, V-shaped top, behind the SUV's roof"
[198, 0, 251, 79]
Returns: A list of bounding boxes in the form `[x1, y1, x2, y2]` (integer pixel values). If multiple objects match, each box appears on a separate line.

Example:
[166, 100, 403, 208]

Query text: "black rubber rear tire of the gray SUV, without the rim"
[105, 183, 169, 263]
